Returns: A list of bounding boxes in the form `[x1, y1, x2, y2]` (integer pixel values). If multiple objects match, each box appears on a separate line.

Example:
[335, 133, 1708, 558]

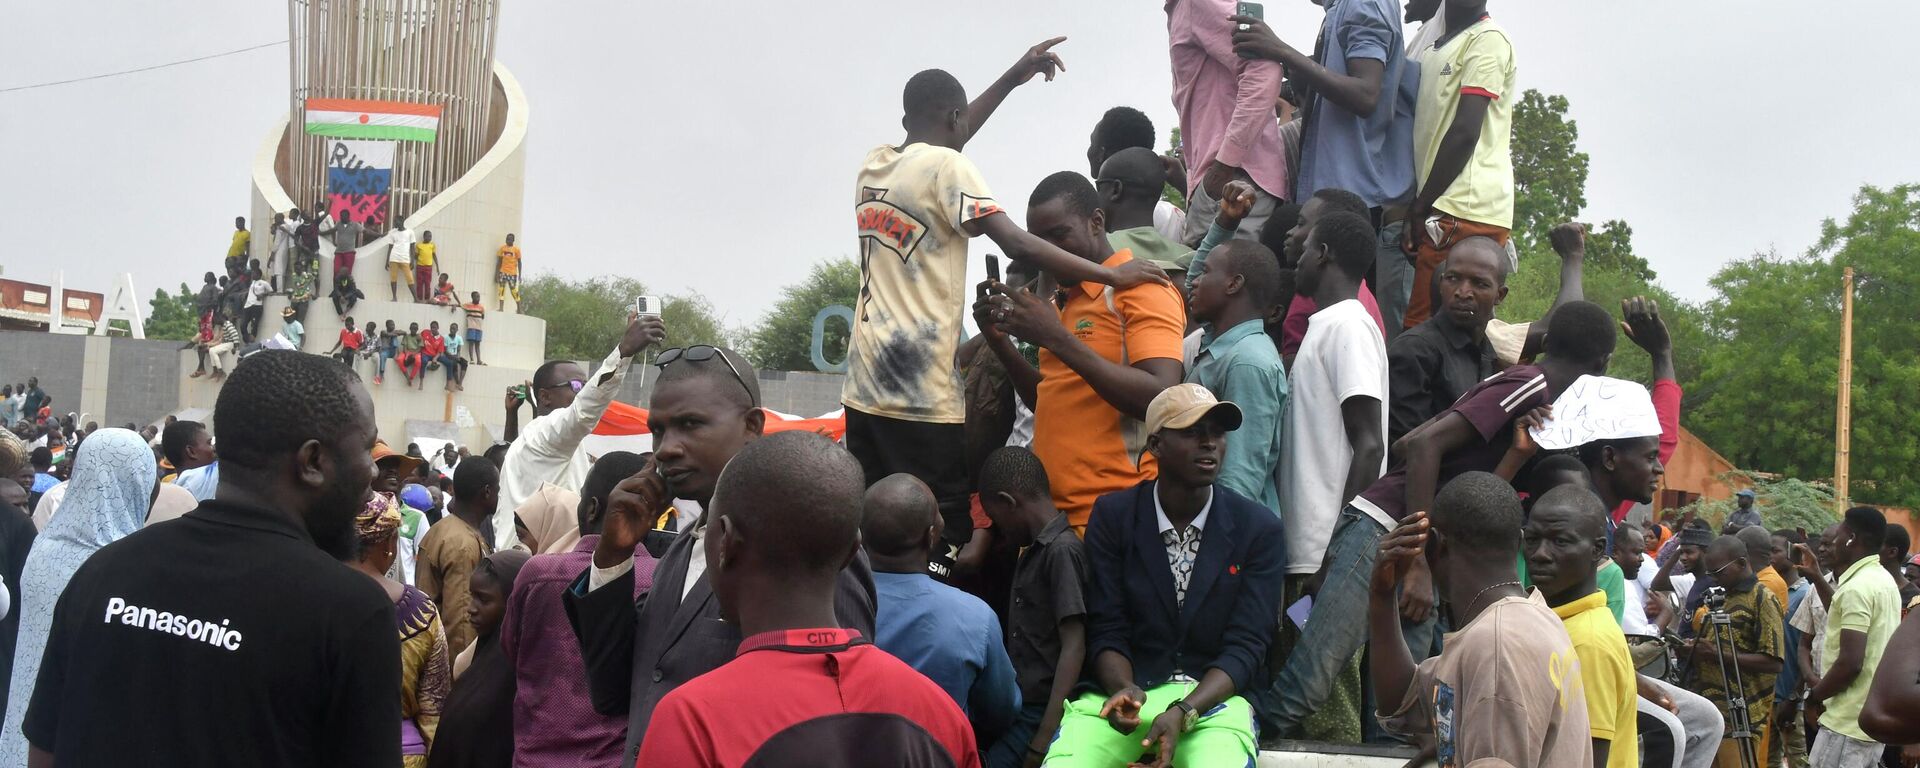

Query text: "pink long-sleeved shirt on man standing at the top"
[1165, 0, 1290, 198]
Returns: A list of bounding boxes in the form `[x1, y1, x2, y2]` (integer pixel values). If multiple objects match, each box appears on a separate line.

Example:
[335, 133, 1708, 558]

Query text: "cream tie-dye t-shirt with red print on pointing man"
[841, 142, 1000, 424]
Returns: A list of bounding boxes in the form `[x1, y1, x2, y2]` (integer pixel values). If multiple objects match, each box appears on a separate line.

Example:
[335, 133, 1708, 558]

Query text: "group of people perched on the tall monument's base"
[184, 204, 520, 387]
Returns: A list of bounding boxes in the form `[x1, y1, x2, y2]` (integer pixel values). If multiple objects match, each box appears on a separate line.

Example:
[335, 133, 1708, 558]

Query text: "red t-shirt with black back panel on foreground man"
[636, 628, 979, 768]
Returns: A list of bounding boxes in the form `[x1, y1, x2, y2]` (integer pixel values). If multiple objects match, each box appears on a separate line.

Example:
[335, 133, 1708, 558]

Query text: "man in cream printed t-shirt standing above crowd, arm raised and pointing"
[860, 38, 1167, 578]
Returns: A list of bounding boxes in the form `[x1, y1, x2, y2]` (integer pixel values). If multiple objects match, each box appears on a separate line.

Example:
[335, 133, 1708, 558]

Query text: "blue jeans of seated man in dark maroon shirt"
[1261, 505, 1434, 739]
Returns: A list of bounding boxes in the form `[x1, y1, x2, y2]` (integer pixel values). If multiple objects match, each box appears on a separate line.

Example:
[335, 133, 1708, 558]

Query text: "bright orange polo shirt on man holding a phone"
[1033, 250, 1187, 532]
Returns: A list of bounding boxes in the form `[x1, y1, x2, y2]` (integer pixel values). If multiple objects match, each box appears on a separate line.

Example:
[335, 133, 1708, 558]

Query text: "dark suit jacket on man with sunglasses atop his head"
[563, 536, 879, 766]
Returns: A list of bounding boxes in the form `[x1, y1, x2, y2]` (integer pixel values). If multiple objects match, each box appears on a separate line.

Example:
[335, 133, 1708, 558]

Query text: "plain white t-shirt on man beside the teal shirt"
[1277, 300, 1386, 574]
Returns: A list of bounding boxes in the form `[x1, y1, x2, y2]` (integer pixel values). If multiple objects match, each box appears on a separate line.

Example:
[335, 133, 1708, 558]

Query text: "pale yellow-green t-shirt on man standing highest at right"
[1413, 19, 1519, 228]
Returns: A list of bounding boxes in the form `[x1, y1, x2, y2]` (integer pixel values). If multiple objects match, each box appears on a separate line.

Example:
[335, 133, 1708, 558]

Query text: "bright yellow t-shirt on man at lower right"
[1553, 591, 1640, 768]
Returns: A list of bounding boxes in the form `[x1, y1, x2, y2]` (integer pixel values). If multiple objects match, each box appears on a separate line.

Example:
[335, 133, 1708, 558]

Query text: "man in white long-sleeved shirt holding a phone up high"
[493, 315, 666, 549]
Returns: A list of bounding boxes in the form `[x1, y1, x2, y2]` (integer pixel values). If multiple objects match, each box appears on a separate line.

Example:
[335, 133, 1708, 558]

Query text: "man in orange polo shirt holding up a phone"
[977, 171, 1187, 536]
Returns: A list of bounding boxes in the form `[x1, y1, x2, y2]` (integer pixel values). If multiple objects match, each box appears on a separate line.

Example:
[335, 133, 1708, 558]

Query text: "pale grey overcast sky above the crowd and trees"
[0, 0, 1920, 326]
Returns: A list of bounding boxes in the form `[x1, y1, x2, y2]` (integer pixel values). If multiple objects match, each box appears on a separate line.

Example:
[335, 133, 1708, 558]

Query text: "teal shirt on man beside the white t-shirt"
[1187, 319, 1286, 515]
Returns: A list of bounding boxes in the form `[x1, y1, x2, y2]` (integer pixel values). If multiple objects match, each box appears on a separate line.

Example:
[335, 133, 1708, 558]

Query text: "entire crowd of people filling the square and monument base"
[0, 0, 1920, 768]
